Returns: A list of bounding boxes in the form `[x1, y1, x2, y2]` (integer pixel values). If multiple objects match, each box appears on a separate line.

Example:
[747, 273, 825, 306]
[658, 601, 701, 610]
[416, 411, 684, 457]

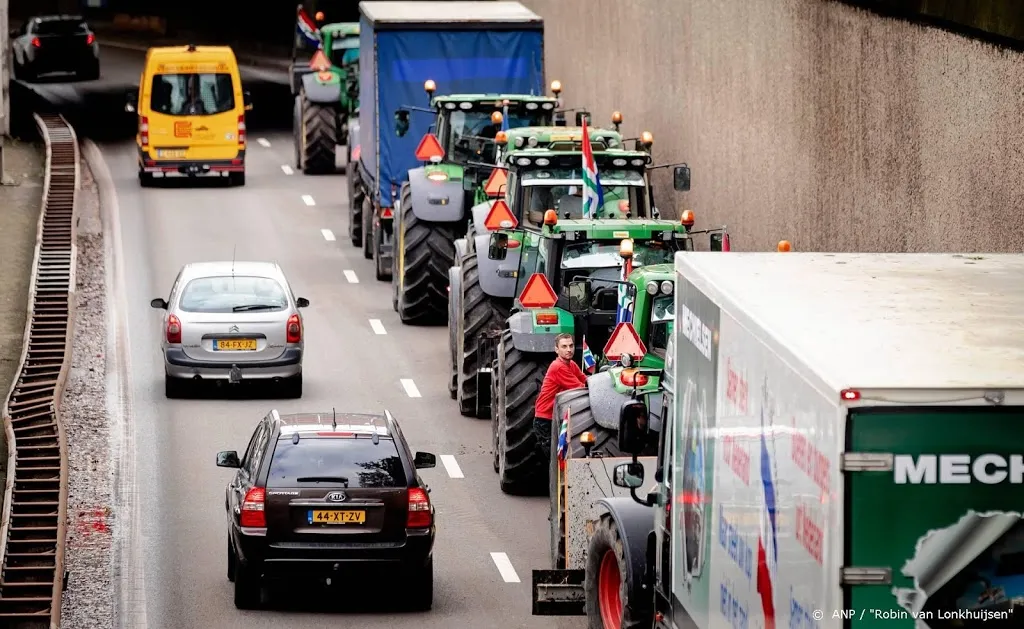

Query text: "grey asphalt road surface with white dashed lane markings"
[19, 48, 585, 629]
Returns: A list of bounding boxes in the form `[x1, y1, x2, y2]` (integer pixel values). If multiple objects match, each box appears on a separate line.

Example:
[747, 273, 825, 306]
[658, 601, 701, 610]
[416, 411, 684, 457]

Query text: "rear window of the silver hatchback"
[178, 276, 288, 312]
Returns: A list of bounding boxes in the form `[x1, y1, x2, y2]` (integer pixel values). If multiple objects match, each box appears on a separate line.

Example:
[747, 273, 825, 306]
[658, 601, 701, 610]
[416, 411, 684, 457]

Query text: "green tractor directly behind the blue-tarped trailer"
[382, 81, 561, 325]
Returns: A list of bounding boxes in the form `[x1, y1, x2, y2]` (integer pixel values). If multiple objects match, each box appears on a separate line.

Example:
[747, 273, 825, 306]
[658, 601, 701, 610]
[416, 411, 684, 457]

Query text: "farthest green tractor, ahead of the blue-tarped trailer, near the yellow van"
[289, 5, 359, 174]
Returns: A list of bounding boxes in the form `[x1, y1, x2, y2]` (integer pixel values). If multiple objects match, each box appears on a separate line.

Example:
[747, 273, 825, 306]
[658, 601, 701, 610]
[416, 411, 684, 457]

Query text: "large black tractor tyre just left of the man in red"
[492, 330, 549, 496]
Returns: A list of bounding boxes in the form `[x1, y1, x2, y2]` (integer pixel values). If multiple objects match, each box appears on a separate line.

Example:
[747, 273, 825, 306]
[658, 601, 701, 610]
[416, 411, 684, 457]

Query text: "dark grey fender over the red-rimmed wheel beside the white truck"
[594, 496, 654, 618]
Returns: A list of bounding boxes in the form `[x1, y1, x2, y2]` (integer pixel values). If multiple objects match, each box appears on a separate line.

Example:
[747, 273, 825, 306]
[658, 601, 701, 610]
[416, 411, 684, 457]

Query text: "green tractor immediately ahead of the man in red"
[481, 217, 728, 494]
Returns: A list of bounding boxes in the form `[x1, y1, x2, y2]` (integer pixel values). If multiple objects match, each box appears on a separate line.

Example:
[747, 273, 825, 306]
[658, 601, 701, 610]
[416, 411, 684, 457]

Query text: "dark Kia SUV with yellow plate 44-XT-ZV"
[217, 410, 436, 610]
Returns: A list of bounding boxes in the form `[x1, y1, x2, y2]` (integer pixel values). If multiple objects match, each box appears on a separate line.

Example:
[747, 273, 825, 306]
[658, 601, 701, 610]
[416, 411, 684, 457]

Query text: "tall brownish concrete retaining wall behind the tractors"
[522, 0, 1024, 251]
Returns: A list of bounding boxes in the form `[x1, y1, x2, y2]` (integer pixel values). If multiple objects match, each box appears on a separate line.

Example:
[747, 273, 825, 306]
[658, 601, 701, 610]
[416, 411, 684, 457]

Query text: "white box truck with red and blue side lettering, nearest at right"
[569, 252, 1024, 629]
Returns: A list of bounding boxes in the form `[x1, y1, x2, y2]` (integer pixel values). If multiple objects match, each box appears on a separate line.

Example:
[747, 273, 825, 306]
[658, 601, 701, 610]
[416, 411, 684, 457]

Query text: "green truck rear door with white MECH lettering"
[844, 406, 1024, 629]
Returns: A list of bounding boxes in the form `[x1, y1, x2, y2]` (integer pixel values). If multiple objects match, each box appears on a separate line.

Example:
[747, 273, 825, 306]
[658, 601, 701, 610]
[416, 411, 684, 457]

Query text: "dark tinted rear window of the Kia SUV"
[266, 436, 406, 488]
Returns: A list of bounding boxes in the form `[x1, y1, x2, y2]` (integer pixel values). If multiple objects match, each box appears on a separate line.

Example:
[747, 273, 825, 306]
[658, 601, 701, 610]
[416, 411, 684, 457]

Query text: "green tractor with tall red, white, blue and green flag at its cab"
[449, 120, 671, 419]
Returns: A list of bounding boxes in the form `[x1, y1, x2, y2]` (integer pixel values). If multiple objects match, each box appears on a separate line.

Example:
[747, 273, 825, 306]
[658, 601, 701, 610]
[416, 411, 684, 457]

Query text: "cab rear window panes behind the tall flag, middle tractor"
[522, 169, 647, 226]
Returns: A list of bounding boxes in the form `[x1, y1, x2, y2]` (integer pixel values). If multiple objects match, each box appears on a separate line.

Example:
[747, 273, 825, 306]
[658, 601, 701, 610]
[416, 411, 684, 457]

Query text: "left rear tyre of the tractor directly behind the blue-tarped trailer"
[393, 181, 456, 325]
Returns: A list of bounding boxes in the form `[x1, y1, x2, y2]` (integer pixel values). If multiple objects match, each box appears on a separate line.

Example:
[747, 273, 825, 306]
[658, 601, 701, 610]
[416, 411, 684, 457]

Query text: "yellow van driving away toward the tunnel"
[125, 45, 252, 186]
